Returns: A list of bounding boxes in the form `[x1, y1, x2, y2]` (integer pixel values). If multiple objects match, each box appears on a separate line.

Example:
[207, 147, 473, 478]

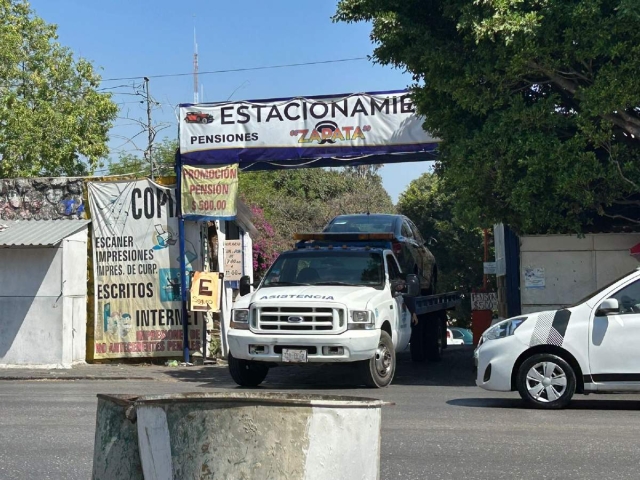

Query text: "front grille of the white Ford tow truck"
[251, 306, 345, 333]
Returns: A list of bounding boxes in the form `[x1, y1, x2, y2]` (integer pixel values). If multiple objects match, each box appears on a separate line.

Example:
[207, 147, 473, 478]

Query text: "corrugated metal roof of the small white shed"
[0, 220, 91, 247]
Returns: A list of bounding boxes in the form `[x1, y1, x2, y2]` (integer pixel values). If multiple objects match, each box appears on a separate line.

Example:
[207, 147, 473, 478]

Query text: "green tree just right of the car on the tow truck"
[398, 173, 484, 326]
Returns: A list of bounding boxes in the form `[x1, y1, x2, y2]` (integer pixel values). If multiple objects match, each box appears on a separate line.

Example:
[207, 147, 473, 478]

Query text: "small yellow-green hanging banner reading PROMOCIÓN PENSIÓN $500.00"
[181, 163, 238, 220]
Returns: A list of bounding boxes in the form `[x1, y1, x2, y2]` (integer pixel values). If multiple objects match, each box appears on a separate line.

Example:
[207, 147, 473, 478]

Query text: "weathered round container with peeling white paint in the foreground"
[94, 392, 384, 480]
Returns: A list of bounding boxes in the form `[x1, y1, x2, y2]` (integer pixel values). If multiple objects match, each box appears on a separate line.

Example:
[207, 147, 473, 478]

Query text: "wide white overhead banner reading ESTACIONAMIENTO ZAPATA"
[180, 91, 439, 168]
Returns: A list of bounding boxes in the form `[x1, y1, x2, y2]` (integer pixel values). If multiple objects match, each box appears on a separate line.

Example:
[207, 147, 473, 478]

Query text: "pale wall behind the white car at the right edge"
[520, 234, 640, 313]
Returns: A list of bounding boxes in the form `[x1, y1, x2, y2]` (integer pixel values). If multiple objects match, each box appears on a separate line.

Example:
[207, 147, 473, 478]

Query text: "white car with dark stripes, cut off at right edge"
[474, 269, 640, 408]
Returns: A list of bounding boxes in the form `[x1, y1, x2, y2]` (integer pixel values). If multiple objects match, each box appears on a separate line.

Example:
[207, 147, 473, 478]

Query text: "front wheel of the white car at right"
[516, 353, 576, 409]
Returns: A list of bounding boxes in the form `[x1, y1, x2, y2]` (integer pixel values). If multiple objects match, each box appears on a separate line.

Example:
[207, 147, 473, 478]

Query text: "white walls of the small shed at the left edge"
[0, 228, 87, 368]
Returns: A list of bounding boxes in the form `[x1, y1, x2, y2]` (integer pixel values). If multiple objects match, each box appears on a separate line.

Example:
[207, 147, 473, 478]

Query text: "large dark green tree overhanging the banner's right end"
[335, 0, 640, 233]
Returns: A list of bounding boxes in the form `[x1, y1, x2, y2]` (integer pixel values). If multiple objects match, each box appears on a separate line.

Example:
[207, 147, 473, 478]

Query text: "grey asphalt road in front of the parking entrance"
[0, 348, 640, 480]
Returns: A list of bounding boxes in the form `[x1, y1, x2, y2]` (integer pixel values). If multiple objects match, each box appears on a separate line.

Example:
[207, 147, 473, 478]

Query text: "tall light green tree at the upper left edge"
[0, 0, 117, 178]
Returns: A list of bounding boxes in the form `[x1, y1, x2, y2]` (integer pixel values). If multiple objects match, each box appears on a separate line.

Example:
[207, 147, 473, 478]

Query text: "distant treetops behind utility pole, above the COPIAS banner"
[107, 138, 178, 177]
